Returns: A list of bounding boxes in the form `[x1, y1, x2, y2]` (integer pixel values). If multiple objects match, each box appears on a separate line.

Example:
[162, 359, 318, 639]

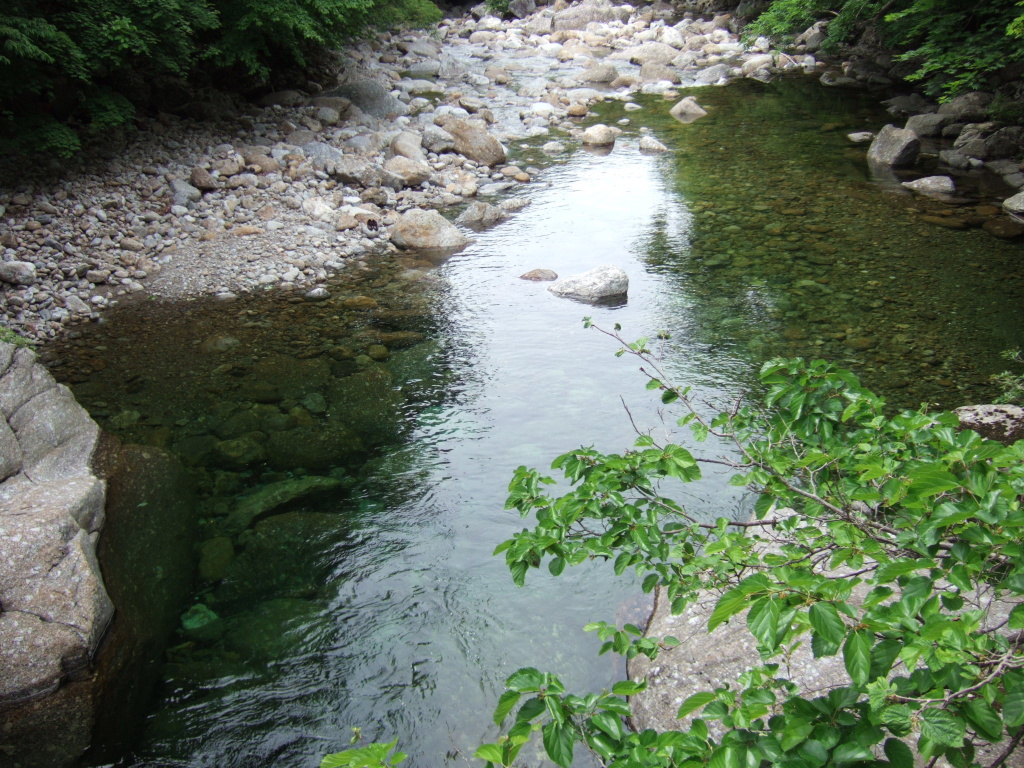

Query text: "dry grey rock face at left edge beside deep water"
[0, 343, 114, 706]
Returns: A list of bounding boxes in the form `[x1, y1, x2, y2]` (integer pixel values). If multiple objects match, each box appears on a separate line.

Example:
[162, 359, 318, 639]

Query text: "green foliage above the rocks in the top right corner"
[749, 0, 1024, 96]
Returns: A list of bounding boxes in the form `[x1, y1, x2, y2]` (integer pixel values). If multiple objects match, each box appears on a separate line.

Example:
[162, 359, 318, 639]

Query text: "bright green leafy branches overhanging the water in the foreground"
[476, 323, 1024, 768]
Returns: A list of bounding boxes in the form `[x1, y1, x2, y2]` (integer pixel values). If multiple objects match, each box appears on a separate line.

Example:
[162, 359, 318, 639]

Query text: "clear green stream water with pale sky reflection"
[47, 75, 1024, 768]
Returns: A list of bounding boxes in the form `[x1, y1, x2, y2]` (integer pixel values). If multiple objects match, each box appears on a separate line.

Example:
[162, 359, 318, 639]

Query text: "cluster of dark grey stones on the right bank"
[851, 91, 1024, 240]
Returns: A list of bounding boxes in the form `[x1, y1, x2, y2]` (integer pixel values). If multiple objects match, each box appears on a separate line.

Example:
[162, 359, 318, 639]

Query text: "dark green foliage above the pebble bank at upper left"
[0, 0, 440, 157]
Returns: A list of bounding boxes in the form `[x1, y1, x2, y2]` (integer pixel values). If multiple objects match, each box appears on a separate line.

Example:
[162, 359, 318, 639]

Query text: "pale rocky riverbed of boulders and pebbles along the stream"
[0, 2, 1024, 340]
